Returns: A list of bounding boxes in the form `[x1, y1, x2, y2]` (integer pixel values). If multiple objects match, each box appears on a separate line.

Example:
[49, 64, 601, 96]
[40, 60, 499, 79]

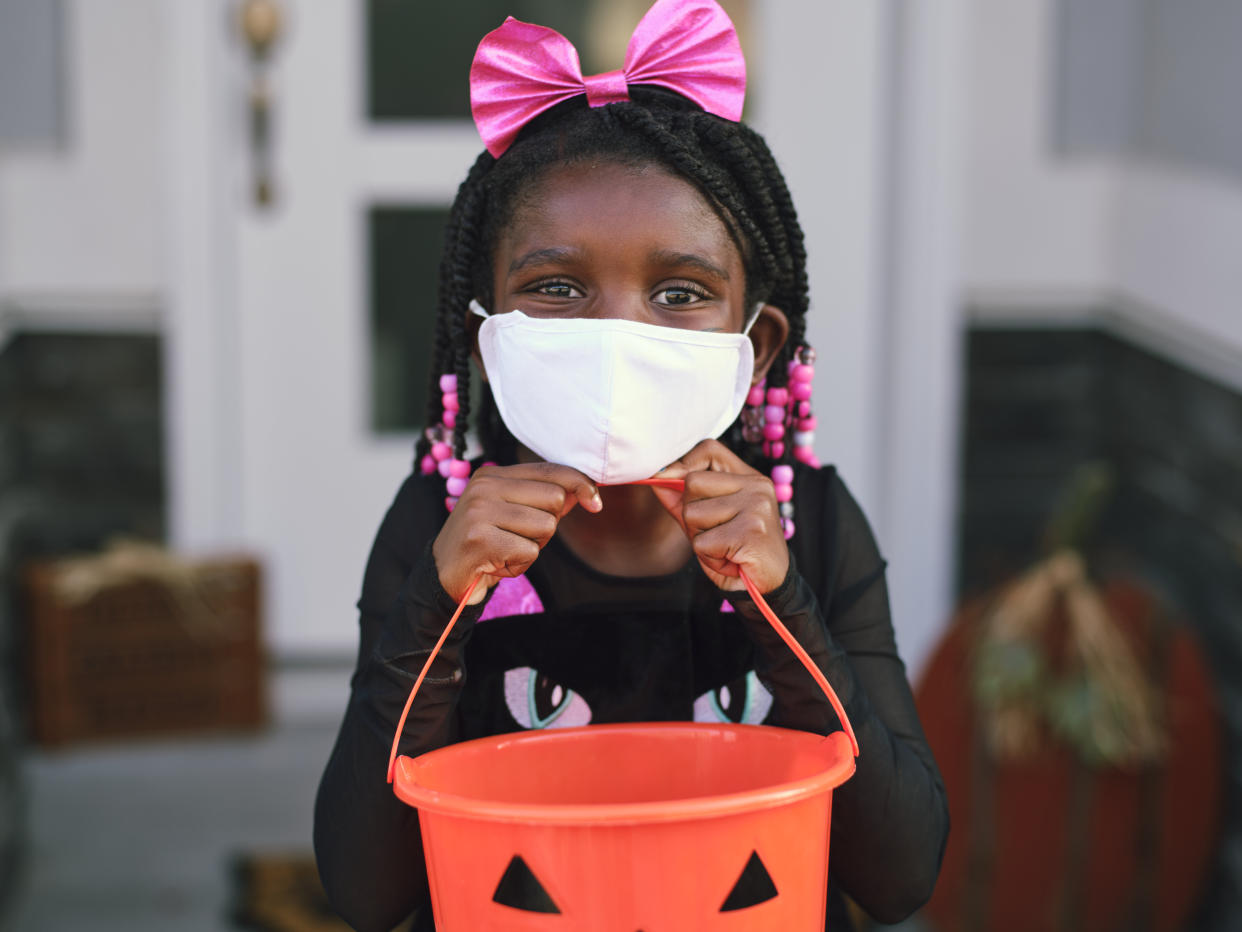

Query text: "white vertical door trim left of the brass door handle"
[160, 0, 245, 549]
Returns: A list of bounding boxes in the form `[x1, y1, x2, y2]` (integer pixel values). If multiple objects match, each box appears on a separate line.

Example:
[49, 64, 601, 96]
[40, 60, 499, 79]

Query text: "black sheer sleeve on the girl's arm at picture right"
[730, 470, 949, 922]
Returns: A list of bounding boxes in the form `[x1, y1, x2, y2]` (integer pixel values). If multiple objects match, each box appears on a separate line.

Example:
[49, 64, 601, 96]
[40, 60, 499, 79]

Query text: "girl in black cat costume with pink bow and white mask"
[314, 0, 948, 932]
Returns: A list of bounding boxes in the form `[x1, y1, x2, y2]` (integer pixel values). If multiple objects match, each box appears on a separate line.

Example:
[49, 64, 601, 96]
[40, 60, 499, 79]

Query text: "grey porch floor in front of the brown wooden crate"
[0, 665, 349, 932]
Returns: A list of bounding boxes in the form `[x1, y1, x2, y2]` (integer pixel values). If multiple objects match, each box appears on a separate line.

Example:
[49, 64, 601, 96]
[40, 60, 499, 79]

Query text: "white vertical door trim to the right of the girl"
[873, 0, 969, 677]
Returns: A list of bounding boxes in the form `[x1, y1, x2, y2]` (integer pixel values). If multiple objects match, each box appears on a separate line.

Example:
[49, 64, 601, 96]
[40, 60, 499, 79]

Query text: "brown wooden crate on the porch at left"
[25, 559, 266, 744]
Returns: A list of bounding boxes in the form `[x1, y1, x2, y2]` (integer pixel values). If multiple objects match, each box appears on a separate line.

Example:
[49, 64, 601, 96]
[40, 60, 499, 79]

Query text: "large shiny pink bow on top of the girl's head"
[469, 0, 746, 157]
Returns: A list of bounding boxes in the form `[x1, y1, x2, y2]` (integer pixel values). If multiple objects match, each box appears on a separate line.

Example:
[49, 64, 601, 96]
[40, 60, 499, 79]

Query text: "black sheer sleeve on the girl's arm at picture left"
[314, 477, 483, 932]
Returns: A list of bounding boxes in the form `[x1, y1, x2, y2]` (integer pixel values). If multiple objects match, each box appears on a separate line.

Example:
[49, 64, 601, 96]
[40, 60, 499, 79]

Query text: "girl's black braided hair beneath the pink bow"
[416, 86, 807, 477]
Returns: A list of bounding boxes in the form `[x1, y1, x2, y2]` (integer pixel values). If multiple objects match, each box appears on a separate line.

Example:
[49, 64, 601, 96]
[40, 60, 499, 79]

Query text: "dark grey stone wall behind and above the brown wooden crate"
[0, 333, 164, 735]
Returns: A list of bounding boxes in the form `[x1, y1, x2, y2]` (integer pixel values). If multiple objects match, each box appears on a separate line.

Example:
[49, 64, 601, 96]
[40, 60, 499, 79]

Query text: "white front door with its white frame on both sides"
[164, 0, 966, 669]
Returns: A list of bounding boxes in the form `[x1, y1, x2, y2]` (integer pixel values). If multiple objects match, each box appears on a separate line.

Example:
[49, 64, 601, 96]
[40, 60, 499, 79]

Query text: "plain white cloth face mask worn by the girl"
[471, 301, 759, 485]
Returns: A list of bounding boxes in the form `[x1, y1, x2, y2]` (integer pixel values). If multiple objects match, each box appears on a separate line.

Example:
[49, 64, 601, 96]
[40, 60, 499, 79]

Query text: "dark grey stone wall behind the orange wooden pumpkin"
[959, 327, 1242, 930]
